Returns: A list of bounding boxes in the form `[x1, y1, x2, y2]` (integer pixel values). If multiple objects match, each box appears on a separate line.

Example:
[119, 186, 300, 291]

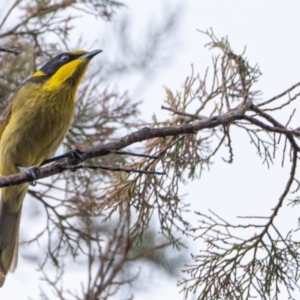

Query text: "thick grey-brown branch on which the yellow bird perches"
[0, 104, 300, 187]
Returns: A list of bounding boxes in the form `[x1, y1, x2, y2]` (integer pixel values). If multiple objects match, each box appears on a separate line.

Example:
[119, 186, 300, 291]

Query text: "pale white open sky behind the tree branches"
[0, 0, 300, 300]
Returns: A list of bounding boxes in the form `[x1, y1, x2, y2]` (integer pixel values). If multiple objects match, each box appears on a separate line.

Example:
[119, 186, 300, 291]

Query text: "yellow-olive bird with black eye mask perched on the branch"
[0, 50, 102, 287]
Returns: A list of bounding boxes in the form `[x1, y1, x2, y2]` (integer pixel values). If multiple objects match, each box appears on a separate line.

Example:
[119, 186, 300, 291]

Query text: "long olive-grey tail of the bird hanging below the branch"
[0, 203, 22, 287]
